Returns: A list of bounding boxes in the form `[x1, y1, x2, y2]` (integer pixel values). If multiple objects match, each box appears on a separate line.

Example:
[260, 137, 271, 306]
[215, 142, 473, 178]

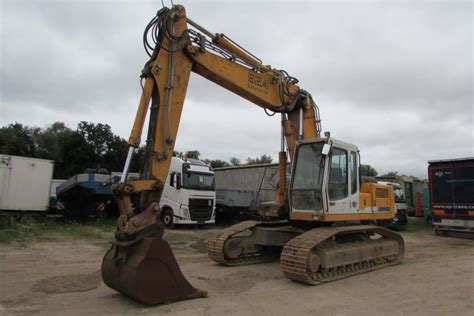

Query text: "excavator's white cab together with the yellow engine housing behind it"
[289, 135, 396, 222]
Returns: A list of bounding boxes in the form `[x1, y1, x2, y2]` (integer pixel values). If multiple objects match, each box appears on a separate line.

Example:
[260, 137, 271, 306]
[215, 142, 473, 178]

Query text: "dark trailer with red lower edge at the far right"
[428, 157, 474, 233]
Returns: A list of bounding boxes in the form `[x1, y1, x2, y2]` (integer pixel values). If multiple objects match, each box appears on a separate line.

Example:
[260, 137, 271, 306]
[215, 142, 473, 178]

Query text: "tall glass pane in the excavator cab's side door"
[329, 148, 348, 200]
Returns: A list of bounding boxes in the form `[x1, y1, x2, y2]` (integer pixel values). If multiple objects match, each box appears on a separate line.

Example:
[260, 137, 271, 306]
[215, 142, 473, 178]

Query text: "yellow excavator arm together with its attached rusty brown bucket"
[102, 5, 320, 304]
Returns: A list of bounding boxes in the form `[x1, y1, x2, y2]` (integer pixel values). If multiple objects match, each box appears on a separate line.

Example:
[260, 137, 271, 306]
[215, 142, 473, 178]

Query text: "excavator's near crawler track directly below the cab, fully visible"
[280, 226, 404, 285]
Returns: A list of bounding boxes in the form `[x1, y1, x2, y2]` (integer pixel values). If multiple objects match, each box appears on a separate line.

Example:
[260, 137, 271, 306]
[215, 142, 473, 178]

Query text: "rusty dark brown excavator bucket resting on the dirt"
[102, 237, 207, 305]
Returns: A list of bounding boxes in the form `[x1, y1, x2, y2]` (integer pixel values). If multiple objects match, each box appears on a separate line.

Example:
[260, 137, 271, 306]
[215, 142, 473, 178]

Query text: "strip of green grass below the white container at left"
[0, 217, 115, 243]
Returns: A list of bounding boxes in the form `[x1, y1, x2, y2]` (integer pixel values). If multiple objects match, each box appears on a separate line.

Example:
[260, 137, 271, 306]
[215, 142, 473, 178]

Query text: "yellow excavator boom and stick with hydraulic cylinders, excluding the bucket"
[115, 5, 320, 228]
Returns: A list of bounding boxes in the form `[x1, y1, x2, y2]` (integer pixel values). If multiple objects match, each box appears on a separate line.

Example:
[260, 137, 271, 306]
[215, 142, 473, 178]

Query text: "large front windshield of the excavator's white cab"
[291, 143, 325, 211]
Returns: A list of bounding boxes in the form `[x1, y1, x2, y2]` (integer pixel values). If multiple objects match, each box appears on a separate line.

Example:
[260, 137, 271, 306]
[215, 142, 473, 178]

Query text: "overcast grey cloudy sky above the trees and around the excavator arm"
[0, 0, 474, 178]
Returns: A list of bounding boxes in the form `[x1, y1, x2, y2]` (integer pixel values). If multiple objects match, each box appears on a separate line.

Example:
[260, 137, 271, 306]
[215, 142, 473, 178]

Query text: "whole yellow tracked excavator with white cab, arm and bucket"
[102, 5, 404, 304]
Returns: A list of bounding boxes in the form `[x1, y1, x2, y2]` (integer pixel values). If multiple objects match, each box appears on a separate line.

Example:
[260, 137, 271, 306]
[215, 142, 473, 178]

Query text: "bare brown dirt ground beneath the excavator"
[0, 229, 474, 315]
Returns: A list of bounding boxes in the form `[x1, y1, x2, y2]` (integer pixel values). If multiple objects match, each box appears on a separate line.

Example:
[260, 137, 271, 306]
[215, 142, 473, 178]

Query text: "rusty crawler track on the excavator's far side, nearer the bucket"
[207, 221, 277, 266]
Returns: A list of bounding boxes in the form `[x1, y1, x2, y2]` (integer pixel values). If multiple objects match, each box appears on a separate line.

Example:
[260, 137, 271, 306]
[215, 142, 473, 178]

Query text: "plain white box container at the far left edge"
[0, 155, 54, 211]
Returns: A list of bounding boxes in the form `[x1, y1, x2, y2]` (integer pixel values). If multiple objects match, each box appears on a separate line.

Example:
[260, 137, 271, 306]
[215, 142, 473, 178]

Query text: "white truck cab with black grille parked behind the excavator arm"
[160, 157, 216, 227]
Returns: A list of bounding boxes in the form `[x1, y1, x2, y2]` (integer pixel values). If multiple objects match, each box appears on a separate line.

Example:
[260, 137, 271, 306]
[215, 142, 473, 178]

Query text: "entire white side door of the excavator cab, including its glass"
[328, 147, 352, 214]
